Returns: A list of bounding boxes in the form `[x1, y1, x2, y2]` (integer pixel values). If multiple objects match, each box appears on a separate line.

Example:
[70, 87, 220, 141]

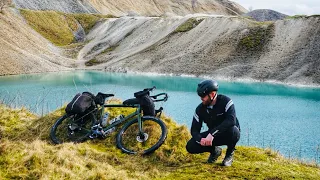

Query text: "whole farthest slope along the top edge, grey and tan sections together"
[13, 0, 247, 16]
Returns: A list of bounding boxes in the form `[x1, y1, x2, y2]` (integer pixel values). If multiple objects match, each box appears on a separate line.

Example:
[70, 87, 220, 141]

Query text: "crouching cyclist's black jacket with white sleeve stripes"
[191, 94, 240, 142]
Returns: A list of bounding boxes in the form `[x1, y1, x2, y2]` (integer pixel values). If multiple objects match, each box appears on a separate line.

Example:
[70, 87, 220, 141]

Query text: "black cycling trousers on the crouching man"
[186, 126, 240, 154]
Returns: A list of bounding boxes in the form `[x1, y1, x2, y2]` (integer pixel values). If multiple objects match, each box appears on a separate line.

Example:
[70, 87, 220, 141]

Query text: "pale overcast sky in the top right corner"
[231, 0, 320, 15]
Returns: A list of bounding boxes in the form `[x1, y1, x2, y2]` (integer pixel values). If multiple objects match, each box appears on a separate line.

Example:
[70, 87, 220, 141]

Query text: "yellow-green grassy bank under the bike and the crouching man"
[0, 105, 320, 179]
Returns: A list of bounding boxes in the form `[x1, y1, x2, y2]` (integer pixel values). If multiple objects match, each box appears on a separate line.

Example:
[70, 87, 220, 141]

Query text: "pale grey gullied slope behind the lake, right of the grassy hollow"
[82, 17, 320, 84]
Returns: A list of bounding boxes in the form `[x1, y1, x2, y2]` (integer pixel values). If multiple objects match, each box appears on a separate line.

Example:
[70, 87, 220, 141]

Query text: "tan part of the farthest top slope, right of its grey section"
[90, 0, 247, 16]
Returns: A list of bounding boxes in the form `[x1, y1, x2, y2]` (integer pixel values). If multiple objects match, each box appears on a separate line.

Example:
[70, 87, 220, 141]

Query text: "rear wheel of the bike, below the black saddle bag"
[50, 114, 94, 144]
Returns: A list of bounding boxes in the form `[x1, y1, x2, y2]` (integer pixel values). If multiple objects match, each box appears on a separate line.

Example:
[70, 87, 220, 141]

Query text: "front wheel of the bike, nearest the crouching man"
[117, 116, 167, 154]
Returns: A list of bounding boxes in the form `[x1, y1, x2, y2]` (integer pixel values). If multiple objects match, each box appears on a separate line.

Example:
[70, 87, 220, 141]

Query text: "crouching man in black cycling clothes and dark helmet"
[186, 80, 240, 166]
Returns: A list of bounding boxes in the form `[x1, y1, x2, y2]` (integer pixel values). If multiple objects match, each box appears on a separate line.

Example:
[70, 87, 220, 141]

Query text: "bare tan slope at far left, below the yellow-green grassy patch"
[0, 10, 74, 75]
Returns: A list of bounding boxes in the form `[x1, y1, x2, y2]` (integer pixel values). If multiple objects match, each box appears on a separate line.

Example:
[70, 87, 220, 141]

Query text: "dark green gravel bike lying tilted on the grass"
[50, 87, 168, 154]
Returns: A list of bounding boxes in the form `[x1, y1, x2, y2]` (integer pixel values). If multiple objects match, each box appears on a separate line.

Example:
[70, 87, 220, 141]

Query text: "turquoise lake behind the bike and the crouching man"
[0, 71, 320, 163]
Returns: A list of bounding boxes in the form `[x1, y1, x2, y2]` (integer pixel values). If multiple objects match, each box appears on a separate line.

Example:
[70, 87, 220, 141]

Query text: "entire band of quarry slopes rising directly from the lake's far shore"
[0, 9, 320, 85]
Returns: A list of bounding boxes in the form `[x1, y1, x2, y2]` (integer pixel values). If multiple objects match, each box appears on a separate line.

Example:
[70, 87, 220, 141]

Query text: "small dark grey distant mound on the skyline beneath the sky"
[243, 9, 288, 21]
